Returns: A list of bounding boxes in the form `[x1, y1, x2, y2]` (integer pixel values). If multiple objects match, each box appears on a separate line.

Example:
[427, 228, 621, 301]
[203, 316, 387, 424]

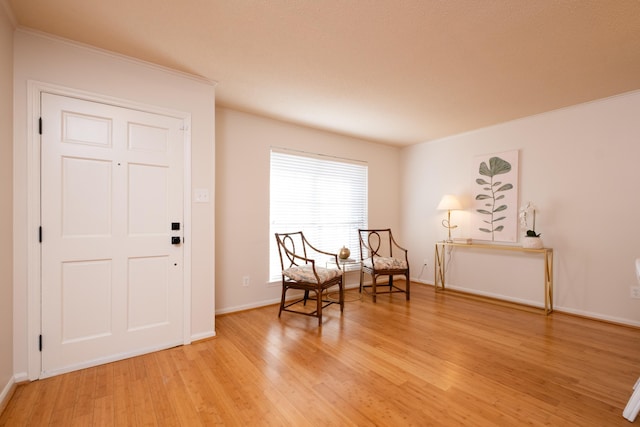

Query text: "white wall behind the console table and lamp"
[402, 92, 640, 325]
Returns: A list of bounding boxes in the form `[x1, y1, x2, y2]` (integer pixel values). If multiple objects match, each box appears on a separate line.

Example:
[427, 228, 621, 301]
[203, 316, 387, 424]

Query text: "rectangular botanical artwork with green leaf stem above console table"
[471, 150, 518, 242]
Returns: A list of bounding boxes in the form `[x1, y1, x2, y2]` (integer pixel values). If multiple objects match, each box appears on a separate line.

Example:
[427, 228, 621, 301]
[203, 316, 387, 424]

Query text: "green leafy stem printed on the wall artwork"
[476, 157, 513, 240]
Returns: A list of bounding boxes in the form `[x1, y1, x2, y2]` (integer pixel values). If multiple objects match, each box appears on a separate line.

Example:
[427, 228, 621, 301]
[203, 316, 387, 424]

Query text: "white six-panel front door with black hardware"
[41, 93, 184, 377]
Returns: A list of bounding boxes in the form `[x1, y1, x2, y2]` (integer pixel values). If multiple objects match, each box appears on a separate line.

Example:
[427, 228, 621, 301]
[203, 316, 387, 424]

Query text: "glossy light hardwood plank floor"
[0, 284, 640, 426]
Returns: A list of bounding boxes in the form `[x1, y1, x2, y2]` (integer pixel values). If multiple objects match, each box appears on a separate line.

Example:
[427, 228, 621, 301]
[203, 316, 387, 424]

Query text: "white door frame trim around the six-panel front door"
[27, 80, 191, 381]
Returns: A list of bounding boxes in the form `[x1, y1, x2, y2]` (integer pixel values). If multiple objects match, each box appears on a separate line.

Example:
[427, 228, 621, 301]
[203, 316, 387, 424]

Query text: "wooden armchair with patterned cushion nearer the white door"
[275, 231, 344, 326]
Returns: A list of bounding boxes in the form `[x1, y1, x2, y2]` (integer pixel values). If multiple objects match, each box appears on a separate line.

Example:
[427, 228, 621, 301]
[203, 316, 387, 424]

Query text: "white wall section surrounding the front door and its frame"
[13, 31, 215, 378]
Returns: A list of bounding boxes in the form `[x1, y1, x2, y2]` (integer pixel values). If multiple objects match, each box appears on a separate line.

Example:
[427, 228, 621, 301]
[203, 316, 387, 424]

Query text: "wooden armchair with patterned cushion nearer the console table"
[358, 228, 410, 302]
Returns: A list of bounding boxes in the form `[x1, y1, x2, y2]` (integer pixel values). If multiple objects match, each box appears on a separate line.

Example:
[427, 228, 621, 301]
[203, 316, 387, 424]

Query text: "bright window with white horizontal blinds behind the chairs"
[269, 149, 368, 281]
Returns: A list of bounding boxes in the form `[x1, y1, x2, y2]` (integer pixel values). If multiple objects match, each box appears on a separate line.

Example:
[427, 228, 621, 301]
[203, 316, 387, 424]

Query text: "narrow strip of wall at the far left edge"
[0, 0, 13, 410]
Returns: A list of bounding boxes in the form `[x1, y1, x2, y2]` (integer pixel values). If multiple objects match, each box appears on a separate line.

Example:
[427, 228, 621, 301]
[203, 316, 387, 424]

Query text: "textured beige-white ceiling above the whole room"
[3, 0, 640, 145]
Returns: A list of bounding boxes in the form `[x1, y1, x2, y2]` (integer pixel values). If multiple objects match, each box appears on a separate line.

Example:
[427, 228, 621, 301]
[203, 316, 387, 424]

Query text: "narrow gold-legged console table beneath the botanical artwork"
[434, 242, 553, 315]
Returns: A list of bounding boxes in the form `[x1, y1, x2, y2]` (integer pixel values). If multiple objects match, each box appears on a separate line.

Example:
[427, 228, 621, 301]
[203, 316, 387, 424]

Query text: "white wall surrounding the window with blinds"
[216, 108, 403, 313]
